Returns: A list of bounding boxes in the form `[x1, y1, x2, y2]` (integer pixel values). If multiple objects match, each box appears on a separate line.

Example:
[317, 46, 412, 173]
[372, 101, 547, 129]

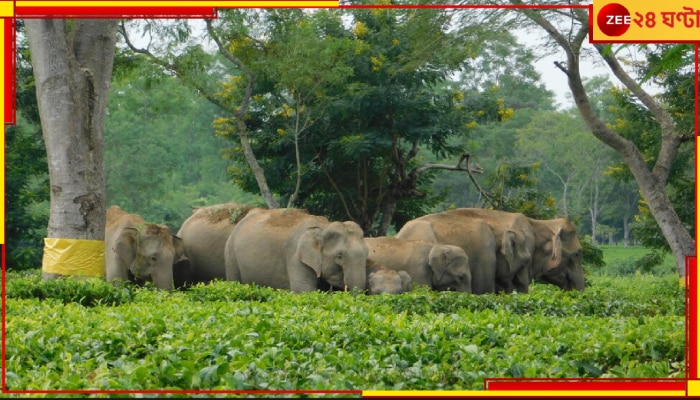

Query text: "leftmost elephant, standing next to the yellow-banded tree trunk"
[105, 205, 189, 290]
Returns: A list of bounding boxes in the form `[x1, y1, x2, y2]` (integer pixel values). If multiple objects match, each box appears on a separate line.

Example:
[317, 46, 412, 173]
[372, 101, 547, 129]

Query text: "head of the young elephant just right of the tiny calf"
[428, 244, 472, 293]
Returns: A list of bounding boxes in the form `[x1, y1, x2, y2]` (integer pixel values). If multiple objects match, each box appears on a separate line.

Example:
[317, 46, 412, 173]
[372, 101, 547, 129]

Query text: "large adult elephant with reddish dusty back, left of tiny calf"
[224, 208, 367, 292]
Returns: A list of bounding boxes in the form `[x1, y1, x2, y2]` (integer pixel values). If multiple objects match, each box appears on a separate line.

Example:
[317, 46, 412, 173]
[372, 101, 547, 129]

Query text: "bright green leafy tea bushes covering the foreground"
[6, 272, 685, 390]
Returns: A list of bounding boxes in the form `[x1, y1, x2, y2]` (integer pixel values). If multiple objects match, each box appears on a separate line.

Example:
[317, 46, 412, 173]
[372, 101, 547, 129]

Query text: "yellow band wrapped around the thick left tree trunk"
[41, 238, 105, 278]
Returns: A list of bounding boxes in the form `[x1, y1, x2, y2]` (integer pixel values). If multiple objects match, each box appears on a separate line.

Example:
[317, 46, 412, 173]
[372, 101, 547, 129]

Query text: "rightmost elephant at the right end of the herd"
[528, 218, 586, 290]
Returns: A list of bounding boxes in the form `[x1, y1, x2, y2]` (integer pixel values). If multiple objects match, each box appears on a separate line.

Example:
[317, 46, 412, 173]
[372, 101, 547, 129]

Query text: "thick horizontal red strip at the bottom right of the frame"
[484, 378, 686, 391]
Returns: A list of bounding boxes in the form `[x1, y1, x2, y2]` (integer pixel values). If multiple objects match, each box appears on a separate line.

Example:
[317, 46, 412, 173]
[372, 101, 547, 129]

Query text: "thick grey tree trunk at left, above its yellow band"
[24, 19, 118, 270]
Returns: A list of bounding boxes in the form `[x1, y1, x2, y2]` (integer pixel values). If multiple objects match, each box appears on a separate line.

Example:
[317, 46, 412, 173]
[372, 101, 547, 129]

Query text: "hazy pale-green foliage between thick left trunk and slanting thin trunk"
[105, 64, 258, 230]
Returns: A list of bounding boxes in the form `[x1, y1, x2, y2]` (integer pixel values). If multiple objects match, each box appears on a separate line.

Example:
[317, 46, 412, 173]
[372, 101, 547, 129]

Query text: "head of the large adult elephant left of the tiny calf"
[297, 221, 368, 290]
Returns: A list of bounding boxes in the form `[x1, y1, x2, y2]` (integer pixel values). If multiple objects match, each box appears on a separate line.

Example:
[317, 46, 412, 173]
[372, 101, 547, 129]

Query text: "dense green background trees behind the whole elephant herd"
[6, 9, 695, 276]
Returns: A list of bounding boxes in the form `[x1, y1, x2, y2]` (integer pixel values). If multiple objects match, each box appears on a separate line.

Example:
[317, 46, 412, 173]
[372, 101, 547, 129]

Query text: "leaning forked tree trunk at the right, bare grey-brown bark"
[500, 0, 695, 277]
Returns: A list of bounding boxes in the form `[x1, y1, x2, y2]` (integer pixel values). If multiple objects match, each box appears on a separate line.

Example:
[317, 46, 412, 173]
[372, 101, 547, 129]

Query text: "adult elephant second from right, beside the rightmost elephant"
[446, 208, 541, 293]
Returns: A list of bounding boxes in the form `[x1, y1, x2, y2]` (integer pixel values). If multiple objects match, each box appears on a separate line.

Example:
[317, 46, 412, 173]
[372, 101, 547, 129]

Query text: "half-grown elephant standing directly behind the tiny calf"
[365, 237, 472, 293]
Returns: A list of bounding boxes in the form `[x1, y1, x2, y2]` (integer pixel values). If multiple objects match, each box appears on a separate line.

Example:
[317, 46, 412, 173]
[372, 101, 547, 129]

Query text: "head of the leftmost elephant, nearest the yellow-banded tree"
[107, 224, 189, 290]
